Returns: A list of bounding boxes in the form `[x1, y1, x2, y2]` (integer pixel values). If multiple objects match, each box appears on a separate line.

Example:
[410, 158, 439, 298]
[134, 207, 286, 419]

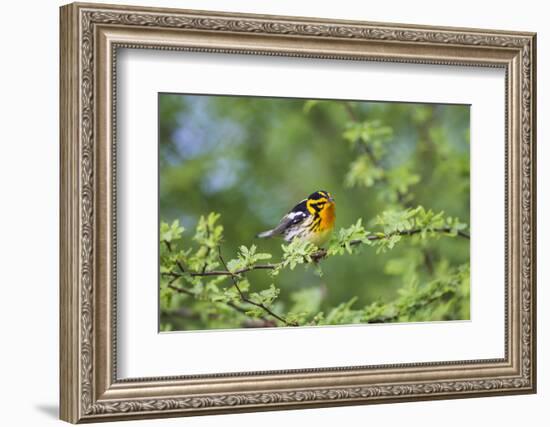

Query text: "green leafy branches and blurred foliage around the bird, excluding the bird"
[159, 94, 470, 330]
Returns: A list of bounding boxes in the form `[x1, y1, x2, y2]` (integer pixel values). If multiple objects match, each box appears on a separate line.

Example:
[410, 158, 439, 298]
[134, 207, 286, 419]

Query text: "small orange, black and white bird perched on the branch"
[256, 190, 336, 247]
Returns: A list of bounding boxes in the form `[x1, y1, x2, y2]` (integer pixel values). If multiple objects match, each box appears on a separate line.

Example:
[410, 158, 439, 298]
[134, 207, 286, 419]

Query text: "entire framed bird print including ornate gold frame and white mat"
[60, 4, 536, 423]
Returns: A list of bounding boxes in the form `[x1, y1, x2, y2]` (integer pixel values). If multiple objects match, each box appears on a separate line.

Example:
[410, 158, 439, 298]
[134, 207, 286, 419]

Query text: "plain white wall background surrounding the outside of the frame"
[0, 0, 550, 427]
